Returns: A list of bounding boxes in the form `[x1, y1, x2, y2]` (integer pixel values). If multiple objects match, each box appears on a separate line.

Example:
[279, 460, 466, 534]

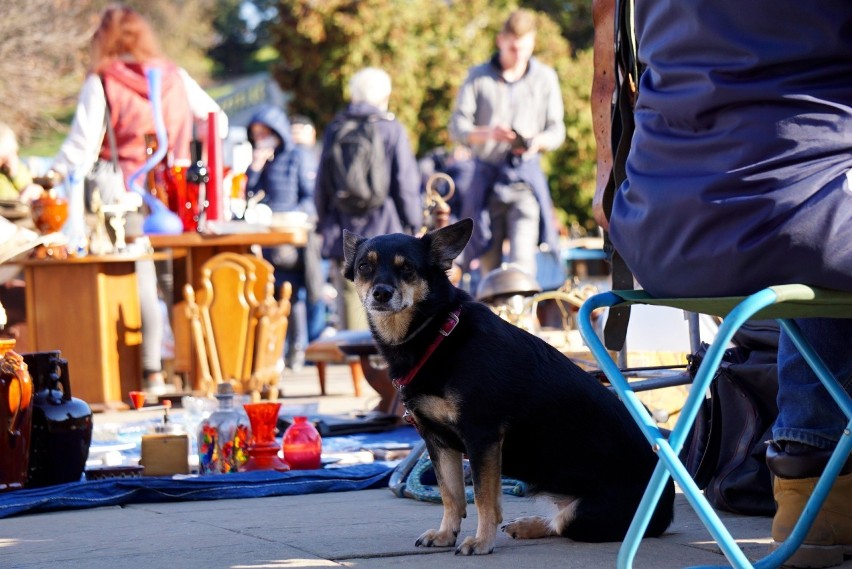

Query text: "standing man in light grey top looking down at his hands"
[450, 10, 565, 277]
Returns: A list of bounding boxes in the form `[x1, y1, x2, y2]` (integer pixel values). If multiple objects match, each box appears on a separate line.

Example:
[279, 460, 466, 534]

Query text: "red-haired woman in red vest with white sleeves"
[53, 4, 227, 395]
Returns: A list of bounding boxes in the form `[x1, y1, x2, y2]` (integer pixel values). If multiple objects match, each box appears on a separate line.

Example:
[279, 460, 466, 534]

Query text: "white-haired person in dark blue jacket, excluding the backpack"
[315, 67, 423, 330]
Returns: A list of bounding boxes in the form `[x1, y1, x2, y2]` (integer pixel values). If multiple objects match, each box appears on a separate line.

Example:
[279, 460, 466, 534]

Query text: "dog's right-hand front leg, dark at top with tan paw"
[456, 442, 503, 555]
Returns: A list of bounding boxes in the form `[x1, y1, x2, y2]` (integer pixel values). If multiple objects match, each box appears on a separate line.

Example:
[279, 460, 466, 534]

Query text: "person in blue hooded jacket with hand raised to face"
[246, 106, 325, 369]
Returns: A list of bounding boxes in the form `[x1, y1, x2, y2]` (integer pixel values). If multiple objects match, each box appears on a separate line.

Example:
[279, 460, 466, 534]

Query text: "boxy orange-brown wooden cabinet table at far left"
[19, 255, 152, 410]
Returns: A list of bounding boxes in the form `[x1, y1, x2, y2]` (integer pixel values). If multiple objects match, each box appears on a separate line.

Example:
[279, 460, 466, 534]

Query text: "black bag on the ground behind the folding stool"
[681, 322, 778, 516]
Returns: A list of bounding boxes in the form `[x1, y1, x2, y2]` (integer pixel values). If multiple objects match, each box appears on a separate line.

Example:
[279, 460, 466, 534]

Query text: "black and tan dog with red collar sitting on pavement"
[344, 219, 674, 555]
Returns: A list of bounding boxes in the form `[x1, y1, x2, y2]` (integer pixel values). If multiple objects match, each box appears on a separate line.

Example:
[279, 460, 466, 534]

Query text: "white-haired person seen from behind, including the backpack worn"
[314, 67, 423, 330]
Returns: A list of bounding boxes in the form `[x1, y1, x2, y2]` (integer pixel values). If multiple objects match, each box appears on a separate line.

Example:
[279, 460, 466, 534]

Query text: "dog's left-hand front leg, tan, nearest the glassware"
[415, 441, 467, 547]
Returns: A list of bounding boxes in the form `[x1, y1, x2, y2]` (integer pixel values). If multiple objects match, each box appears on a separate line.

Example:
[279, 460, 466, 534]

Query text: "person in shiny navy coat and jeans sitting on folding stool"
[592, 0, 852, 567]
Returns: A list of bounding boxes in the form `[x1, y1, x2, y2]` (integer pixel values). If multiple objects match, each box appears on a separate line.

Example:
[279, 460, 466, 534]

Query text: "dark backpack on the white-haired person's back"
[323, 115, 390, 215]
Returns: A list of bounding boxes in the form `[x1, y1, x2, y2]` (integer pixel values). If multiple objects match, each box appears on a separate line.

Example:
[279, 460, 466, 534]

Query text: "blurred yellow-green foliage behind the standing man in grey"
[270, 0, 595, 231]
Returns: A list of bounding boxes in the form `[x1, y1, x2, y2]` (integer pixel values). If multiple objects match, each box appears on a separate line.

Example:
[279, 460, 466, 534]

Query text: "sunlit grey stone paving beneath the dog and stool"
[0, 368, 852, 569]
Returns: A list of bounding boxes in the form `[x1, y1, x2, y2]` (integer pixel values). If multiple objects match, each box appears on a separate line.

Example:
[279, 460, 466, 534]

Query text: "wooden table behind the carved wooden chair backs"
[148, 229, 311, 389]
